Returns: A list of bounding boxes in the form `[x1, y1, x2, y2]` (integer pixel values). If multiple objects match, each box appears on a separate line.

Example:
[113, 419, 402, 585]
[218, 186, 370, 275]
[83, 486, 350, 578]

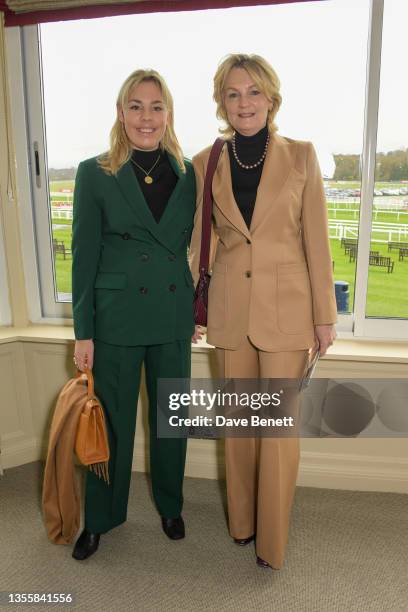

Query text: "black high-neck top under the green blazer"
[131, 149, 178, 223]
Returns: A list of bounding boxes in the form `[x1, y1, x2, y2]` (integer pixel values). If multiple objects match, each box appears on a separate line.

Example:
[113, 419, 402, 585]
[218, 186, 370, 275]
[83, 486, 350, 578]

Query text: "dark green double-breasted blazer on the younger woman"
[72, 155, 195, 346]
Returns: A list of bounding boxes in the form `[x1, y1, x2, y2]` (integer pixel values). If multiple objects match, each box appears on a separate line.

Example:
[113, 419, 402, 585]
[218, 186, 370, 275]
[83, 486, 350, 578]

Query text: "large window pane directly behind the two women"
[41, 0, 369, 310]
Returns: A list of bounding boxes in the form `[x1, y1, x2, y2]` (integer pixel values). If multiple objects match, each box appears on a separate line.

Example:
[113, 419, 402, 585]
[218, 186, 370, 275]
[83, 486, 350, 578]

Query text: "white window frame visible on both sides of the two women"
[6, 0, 408, 340]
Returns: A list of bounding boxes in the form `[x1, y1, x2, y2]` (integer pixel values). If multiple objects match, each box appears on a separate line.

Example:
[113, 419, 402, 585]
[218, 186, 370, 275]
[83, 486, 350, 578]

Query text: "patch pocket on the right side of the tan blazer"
[277, 263, 313, 334]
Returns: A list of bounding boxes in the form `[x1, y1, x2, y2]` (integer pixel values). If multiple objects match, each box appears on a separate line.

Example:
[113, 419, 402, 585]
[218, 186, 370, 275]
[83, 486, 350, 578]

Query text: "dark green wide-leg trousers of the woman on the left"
[85, 339, 191, 533]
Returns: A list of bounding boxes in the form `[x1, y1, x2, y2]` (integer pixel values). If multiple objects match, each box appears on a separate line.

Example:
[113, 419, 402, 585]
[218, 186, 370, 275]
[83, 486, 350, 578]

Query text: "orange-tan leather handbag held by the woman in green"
[75, 369, 109, 484]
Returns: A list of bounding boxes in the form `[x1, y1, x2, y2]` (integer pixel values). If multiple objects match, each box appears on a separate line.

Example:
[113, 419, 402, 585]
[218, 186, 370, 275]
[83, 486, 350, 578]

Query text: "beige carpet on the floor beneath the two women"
[0, 463, 408, 612]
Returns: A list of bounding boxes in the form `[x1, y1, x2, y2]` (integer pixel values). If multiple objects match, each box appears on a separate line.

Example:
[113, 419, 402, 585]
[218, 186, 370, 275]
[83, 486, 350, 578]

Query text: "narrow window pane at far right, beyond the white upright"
[366, 0, 408, 318]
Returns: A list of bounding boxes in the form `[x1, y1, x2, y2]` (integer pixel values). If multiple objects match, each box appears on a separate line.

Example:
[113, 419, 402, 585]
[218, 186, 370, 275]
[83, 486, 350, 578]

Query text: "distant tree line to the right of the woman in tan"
[333, 149, 408, 181]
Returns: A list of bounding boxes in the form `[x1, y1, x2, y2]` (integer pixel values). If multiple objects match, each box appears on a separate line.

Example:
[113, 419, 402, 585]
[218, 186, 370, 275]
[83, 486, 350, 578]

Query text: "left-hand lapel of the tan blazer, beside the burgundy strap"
[213, 144, 251, 238]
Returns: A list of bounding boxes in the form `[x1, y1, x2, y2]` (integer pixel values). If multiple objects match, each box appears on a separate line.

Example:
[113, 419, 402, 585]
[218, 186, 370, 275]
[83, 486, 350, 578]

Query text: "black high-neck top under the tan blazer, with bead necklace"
[228, 126, 268, 228]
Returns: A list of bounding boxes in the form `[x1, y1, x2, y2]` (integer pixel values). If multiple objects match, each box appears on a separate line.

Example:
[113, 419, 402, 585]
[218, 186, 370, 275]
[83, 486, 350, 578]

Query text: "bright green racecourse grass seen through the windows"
[50, 181, 408, 318]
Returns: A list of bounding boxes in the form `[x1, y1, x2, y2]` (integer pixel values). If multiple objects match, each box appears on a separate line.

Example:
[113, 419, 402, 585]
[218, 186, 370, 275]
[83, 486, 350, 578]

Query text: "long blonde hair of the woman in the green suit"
[98, 69, 186, 174]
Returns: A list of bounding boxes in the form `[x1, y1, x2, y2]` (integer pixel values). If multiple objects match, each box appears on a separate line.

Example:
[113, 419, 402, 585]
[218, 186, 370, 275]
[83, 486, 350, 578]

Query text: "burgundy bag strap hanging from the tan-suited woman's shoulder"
[200, 138, 225, 275]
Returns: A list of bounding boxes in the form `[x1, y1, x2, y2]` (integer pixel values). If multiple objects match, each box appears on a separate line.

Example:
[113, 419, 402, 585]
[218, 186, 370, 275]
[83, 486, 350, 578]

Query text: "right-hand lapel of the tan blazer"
[251, 134, 296, 233]
